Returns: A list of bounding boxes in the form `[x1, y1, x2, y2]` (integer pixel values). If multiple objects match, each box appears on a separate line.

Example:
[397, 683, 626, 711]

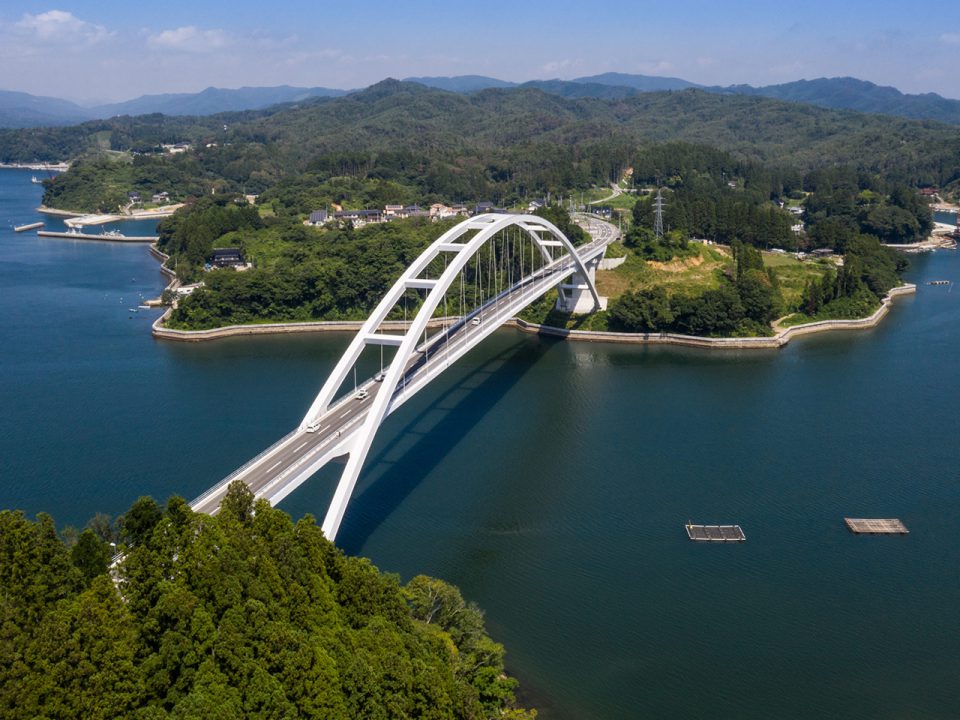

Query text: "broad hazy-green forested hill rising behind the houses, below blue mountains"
[189, 80, 960, 168]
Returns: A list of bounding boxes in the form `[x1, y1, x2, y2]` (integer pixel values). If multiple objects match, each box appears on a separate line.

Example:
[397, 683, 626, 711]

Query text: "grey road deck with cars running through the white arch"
[190, 216, 619, 514]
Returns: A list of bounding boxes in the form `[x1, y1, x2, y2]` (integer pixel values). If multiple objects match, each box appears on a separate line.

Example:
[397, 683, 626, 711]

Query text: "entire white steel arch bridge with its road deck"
[191, 214, 617, 540]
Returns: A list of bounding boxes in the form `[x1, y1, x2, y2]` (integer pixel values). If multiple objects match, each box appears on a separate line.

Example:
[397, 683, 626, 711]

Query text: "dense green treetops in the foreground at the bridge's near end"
[0, 484, 535, 720]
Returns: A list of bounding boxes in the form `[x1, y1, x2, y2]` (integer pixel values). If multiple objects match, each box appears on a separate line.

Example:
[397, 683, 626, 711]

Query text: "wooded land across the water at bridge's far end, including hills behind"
[7, 80, 944, 336]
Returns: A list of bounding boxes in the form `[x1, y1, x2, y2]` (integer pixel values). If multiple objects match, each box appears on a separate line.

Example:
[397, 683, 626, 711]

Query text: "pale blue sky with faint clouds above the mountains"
[0, 0, 960, 101]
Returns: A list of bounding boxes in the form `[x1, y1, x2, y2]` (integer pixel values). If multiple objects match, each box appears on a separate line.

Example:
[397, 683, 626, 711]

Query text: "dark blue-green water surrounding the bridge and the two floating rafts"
[0, 172, 960, 720]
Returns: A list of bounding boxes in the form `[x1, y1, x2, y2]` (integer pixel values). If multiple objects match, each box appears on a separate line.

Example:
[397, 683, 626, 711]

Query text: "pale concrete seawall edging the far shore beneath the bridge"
[151, 282, 917, 350]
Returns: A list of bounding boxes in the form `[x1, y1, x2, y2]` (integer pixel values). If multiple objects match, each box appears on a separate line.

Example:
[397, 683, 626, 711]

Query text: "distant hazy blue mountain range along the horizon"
[0, 73, 960, 128]
